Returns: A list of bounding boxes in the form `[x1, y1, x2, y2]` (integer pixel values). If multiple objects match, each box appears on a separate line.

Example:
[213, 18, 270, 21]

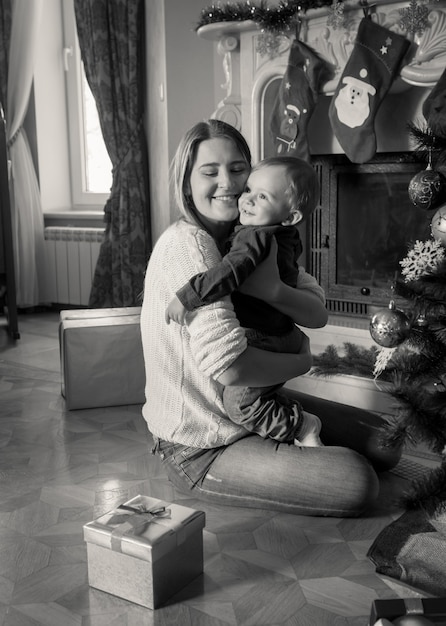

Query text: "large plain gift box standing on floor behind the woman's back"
[59, 307, 145, 409]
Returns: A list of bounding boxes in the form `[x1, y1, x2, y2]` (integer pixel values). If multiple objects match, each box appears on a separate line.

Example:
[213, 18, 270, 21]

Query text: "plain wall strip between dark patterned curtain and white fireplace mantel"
[146, 0, 215, 241]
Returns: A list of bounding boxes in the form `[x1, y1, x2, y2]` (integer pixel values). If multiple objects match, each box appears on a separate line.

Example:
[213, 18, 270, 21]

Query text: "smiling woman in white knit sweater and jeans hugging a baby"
[141, 120, 398, 517]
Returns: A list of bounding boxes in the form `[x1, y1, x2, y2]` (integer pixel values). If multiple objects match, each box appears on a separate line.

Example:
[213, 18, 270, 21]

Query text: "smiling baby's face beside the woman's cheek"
[238, 166, 290, 226]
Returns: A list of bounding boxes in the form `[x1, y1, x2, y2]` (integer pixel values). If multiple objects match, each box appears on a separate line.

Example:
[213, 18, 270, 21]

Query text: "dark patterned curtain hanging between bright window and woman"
[74, 0, 151, 308]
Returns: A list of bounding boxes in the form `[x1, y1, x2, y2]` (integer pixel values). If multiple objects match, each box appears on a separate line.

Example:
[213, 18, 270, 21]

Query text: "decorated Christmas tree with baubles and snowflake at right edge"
[370, 70, 446, 512]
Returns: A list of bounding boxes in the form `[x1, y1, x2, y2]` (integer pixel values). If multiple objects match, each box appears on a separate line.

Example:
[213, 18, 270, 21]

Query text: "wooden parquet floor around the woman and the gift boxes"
[0, 311, 440, 626]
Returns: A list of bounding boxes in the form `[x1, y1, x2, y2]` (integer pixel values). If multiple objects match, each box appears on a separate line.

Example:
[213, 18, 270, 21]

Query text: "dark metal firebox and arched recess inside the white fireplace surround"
[259, 86, 430, 317]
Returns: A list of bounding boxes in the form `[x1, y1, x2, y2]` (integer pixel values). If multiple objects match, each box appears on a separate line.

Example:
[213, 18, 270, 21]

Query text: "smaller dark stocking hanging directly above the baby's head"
[270, 40, 333, 161]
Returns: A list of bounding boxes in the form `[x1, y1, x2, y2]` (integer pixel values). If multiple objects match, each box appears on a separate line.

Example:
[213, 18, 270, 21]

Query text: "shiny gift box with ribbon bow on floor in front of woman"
[84, 496, 205, 609]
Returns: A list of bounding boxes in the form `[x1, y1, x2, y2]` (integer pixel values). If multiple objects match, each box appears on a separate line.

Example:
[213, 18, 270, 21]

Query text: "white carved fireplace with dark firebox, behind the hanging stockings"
[198, 0, 446, 324]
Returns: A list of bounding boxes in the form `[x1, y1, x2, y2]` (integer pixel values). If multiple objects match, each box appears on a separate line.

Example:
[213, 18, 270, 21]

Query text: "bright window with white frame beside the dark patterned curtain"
[62, 0, 112, 208]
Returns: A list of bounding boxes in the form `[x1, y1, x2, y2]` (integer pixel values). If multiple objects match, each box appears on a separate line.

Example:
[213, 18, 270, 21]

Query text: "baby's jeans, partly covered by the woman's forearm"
[223, 326, 303, 443]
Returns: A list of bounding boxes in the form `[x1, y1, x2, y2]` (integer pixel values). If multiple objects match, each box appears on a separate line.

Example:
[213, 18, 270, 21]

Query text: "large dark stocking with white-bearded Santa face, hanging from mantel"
[329, 18, 410, 163]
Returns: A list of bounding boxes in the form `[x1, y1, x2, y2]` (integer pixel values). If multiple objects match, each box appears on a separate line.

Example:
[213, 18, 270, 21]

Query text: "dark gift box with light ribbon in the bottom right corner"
[369, 598, 446, 626]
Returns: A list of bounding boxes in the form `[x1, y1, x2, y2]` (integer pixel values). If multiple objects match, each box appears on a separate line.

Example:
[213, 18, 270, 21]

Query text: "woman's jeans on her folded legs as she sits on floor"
[153, 390, 401, 517]
